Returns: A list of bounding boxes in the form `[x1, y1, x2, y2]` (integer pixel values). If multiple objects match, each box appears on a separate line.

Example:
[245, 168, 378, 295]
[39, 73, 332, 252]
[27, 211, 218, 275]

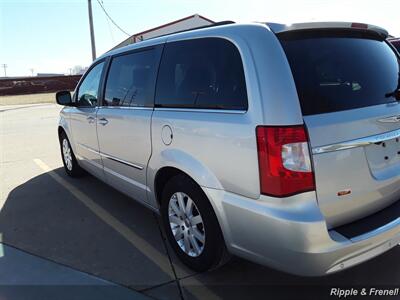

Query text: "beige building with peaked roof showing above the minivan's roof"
[113, 14, 215, 49]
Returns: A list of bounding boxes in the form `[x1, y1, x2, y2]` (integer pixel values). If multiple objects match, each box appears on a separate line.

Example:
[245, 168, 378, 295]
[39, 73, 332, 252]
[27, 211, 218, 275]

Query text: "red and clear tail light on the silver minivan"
[256, 125, 315, 197]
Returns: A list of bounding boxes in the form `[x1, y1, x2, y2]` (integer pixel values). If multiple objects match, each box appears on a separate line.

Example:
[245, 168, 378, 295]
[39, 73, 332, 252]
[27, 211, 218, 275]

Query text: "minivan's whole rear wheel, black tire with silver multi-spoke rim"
[161, 175, 225, 271]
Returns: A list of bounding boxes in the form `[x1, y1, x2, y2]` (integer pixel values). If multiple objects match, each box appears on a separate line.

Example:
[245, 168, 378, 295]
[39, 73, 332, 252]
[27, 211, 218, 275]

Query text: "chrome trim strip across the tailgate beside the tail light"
[312, 129, 400, 154]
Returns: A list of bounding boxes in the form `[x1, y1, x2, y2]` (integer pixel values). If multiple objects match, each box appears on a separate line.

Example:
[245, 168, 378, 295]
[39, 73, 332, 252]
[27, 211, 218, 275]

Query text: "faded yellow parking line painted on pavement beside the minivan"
[33, 158, 221, 300]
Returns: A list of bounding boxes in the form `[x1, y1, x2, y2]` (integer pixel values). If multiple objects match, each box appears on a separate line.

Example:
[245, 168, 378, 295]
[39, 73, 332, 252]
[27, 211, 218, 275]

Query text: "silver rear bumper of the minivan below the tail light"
[203, 188, 400, 276]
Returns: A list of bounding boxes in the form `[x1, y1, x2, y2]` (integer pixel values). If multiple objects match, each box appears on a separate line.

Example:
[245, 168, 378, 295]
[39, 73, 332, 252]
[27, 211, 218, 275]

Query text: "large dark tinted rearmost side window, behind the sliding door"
[155, 38, 247, 110]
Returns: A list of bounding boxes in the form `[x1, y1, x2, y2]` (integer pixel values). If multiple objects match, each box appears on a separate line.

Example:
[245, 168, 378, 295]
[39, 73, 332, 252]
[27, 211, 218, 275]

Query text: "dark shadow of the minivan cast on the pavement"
[0, 168, 400, 299]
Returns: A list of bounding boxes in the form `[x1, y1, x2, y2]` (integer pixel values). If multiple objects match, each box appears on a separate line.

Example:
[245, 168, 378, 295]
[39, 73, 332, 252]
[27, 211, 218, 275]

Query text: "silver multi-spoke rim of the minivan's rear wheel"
[168, 192, 206, 257]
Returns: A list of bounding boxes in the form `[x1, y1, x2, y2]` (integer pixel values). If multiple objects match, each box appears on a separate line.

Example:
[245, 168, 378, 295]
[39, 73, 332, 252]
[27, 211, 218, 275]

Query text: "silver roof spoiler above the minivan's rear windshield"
[265, 22, 389, 38]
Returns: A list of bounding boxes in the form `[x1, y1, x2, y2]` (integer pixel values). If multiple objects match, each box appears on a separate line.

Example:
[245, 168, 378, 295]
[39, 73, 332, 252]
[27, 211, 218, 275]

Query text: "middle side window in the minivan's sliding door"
[103, 49, 157, 106]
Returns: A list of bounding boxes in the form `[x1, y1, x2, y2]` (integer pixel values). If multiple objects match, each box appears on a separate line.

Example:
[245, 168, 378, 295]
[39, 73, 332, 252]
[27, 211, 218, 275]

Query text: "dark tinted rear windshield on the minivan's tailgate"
[278, 33, 400, 115]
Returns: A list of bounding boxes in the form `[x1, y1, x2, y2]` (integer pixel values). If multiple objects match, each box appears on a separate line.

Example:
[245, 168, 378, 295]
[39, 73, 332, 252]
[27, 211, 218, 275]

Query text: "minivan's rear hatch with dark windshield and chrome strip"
[277, 28, 400, 228]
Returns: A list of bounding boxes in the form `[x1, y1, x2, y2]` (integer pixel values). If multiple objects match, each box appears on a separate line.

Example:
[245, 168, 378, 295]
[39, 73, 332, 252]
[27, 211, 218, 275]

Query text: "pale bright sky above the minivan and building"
[0, 0, 400, 76]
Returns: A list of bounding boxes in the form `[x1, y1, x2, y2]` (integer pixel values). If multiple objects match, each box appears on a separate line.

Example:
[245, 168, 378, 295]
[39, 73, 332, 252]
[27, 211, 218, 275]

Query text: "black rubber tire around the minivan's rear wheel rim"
[161, 174, 227, 272]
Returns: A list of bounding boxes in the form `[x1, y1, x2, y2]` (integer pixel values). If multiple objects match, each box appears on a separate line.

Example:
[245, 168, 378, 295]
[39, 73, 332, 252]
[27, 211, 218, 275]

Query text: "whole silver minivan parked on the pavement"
[57, 23, 400, 275]
